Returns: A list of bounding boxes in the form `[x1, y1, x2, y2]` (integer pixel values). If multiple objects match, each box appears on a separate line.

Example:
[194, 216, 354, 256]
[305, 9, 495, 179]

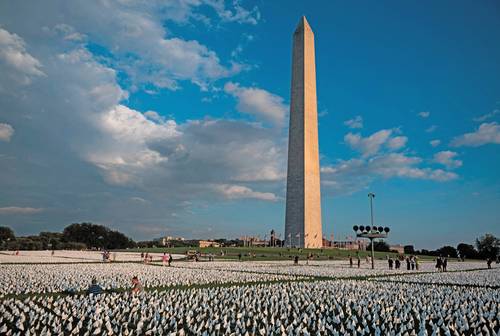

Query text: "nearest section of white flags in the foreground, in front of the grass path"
[0, 280, 500, 335]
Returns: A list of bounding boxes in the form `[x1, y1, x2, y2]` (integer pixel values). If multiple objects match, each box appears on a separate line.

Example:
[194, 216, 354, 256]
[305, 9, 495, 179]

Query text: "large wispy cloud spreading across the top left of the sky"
[2, 1, 258, 90]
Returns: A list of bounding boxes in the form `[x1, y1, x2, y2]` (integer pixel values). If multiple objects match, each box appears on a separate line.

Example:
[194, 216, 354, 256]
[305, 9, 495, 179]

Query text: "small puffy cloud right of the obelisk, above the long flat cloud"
[344, 129, 408, 157]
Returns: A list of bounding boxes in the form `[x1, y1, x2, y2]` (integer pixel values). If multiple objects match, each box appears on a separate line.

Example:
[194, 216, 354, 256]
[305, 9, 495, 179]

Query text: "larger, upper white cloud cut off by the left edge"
[0, 28, 45, 85]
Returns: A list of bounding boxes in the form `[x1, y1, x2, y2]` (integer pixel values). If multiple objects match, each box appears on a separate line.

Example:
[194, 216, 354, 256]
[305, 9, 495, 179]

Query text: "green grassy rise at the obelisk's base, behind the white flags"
[116, 247, 442, 260]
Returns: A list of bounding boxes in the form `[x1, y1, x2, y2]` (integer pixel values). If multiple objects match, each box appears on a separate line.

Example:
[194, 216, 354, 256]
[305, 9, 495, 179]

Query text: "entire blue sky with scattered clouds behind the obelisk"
[0, 0, 500, 248]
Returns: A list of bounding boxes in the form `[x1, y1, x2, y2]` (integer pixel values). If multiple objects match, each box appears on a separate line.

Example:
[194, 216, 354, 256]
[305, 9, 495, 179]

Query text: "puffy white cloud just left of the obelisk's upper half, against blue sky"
[224, 82, 288, 125]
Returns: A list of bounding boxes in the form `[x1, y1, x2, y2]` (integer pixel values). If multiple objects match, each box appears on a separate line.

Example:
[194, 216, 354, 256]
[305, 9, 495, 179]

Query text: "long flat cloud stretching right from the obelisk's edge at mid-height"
[321, 153, 458, 193]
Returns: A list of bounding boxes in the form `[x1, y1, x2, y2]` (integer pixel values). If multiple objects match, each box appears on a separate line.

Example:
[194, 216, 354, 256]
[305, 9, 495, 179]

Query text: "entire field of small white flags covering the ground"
[0, 251, 500, 335]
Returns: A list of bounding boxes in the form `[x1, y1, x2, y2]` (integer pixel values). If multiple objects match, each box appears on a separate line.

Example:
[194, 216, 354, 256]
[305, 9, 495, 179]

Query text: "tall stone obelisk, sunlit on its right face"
[285, 16, 323, 248]
